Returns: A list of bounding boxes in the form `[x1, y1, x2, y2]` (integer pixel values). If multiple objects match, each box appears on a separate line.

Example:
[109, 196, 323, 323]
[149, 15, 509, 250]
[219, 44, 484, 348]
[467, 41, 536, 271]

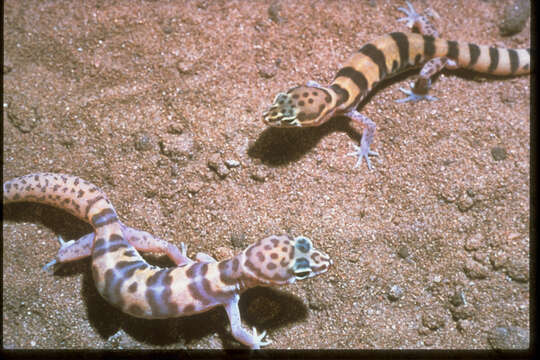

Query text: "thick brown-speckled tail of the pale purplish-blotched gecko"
[3, 173, 118, 228]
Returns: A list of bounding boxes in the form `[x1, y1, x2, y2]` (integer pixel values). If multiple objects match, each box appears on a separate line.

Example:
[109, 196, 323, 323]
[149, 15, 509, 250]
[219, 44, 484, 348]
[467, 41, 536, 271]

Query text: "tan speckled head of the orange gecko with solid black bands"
[263, 85, 336, 127]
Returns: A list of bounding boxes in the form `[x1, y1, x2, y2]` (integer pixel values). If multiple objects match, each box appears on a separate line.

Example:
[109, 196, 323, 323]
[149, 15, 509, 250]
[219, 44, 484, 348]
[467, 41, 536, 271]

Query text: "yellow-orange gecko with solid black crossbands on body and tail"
[263, 2, 531, 169]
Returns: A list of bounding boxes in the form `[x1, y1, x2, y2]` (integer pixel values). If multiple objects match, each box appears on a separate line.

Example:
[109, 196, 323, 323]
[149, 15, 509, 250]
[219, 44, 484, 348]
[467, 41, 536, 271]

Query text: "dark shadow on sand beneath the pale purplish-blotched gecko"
[3, 202, 307, 348]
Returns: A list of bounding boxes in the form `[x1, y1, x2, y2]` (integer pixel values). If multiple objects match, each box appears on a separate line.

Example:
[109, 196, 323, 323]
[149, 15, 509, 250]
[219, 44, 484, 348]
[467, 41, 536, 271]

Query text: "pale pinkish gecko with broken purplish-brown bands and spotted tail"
[3, 173, 332, 349]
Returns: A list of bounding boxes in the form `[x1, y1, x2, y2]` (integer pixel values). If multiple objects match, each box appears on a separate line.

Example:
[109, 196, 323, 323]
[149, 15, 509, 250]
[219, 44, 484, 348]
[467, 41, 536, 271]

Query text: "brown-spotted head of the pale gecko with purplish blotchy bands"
[243, 235, 332, 285]
